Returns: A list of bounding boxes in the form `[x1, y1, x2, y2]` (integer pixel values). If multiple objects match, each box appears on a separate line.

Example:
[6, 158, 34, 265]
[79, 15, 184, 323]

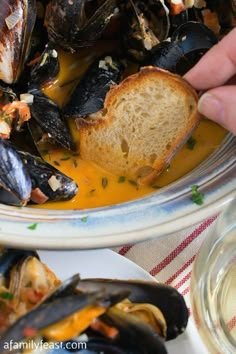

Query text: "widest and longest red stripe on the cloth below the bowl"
[149, 216, 217, 276]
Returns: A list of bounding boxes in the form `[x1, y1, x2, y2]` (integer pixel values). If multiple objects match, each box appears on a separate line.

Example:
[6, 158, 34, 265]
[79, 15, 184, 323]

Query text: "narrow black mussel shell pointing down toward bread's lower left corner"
[30, 91, 75, 150]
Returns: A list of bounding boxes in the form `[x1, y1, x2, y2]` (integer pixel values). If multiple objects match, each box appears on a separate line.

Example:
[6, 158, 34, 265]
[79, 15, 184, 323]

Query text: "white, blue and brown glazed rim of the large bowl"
[0, 134, 236, 249]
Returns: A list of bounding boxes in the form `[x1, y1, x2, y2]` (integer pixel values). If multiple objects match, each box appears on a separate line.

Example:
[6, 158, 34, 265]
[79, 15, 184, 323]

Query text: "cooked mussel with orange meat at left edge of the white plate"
[0, 249, 60, 337]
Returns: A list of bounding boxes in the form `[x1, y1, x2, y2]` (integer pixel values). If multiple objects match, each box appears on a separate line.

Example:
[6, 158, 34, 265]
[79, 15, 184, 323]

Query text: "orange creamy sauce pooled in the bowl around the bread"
[36, 44, 226, 209]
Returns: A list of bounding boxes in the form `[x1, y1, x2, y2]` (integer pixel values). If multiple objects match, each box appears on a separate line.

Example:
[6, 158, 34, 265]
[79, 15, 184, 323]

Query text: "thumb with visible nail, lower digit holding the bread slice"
[198, 86, 236, 135]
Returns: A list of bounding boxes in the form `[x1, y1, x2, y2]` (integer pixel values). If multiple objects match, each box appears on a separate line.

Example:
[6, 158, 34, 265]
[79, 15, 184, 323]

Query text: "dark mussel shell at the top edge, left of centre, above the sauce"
[45, 0, 117, 52]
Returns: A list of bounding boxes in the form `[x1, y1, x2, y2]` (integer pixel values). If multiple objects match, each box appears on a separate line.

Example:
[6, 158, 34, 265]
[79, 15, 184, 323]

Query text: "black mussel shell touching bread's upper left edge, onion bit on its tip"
[63, 56, 124, 118]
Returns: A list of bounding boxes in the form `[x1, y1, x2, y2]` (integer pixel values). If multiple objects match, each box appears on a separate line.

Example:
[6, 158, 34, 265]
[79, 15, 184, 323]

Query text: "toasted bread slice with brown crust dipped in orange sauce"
[78, 67, 199, 184]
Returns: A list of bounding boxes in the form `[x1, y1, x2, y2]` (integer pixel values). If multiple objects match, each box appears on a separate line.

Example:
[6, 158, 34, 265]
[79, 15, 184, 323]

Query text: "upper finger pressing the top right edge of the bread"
[184, 28, 236, 90]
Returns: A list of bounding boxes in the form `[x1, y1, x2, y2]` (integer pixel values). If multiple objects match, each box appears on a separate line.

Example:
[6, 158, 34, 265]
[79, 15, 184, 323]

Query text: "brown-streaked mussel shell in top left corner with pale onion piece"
[0, 0, 36, 84]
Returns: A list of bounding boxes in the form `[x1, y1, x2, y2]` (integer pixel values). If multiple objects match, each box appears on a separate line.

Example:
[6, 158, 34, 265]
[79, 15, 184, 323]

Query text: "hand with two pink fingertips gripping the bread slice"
[184, 28, 236, 135]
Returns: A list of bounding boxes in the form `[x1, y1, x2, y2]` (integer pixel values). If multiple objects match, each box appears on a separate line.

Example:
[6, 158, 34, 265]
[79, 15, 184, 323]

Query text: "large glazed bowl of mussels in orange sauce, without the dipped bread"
[0, 0, 236, 249]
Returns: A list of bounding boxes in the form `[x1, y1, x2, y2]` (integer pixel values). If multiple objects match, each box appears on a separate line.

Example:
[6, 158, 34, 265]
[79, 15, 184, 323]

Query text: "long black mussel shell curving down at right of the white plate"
[78, 279, 188, 340]
